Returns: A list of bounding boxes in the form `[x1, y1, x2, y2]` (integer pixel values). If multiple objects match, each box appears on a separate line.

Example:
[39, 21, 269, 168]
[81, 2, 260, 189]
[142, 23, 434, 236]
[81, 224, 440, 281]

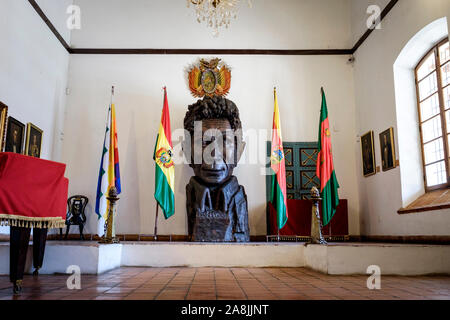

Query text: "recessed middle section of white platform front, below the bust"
[122, 242, 305, 267]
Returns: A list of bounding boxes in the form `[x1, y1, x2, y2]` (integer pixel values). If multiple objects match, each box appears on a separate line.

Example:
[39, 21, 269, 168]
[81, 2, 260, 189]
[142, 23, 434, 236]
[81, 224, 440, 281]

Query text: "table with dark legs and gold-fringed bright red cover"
[0, 153, 69, 291]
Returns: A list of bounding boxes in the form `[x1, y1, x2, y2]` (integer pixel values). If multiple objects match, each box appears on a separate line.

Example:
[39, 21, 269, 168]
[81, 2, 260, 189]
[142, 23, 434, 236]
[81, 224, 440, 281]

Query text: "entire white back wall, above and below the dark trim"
[58, 0, 359, 235]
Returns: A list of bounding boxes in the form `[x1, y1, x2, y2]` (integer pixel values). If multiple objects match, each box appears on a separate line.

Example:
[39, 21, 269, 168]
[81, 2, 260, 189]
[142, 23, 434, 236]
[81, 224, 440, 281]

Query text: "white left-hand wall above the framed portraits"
[0, 0, 70, 232]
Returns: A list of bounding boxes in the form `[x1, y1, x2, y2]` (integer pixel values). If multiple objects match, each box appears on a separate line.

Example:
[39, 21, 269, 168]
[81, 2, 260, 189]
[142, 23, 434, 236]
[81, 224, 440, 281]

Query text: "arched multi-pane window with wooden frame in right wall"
[416, 38, 450, 191]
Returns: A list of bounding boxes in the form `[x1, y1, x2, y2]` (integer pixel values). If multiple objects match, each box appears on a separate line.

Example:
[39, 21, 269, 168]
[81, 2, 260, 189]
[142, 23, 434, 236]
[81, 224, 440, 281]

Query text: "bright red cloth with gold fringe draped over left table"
[0, 153, 69, 228]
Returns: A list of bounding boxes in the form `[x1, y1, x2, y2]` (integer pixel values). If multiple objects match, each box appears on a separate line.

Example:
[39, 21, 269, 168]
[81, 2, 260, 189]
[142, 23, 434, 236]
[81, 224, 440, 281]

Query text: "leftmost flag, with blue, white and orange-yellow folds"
[95, 104, 122, 237]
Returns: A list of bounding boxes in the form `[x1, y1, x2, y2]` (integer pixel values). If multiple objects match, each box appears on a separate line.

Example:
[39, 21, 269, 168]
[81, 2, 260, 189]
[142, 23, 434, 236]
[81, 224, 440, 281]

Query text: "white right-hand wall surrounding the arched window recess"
[354, 0, 450, 235]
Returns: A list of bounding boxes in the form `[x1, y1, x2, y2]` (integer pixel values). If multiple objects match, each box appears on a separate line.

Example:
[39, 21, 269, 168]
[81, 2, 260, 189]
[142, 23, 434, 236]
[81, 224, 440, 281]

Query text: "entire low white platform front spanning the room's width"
[0, 241, 450, 275]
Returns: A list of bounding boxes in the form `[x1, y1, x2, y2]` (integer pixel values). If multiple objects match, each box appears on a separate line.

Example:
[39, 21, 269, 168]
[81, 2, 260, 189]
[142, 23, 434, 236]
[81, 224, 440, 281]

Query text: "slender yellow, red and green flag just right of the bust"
[270, 89, 288, 230]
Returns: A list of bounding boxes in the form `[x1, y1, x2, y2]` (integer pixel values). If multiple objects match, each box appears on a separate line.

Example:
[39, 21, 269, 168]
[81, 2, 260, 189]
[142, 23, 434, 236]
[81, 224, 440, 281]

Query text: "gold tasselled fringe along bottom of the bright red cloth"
[0, 214, 66, 229]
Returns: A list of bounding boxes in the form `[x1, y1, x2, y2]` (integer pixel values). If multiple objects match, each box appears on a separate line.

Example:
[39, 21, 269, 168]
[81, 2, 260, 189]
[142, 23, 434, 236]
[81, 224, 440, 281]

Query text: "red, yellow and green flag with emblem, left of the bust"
[153, 88, 175, 219]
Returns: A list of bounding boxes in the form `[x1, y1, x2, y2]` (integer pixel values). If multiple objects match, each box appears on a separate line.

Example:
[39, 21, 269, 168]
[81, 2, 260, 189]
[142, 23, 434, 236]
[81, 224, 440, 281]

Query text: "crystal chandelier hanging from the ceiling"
[187, 0, 252, 37]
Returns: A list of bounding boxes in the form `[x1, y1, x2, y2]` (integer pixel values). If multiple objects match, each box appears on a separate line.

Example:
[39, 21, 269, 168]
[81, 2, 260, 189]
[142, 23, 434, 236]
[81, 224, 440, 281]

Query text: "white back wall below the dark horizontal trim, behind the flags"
[63, 55, 359, 235]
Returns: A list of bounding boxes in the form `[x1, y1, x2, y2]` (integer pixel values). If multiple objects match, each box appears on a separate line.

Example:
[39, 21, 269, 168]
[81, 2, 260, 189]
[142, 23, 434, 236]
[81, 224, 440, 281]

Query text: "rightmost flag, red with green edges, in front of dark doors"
[316, 88, 339, 226]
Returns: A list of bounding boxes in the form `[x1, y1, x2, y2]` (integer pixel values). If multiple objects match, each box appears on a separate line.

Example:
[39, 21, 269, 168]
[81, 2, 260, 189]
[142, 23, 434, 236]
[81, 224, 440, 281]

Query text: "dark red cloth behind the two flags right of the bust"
[267, 200, 348, 237]
